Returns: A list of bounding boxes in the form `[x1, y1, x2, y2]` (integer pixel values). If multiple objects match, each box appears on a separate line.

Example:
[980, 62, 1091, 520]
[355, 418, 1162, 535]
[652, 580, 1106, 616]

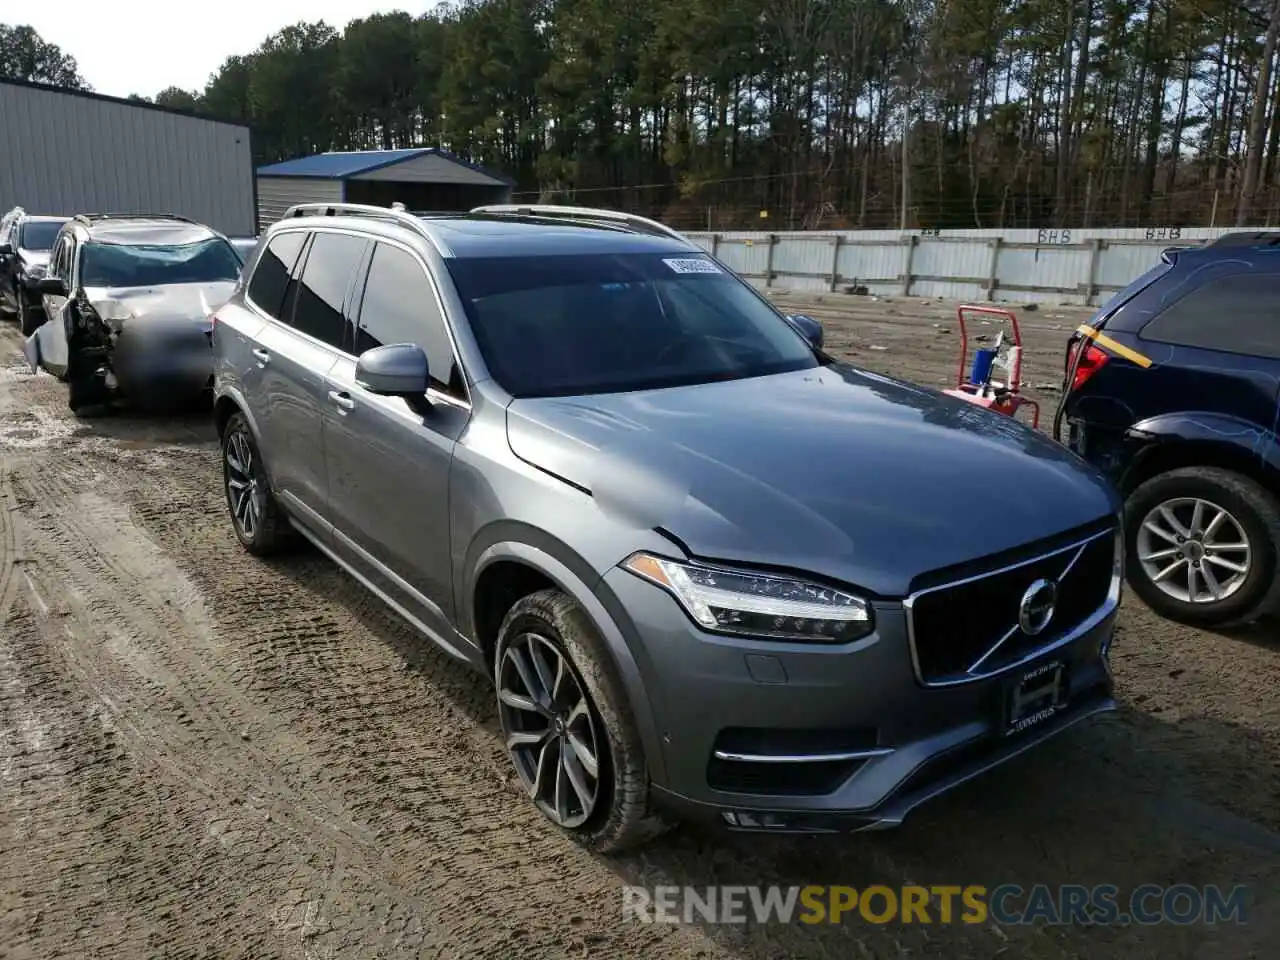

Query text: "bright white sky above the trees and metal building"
[17, 0, 435, 97]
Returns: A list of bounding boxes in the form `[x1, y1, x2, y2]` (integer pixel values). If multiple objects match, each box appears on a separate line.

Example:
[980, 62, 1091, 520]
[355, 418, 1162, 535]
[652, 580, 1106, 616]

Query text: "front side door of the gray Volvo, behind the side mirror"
[325, 239, 471, 644]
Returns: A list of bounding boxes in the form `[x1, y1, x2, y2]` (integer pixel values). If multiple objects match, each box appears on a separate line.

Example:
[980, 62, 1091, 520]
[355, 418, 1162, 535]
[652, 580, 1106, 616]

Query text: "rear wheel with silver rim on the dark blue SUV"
[1125, 467, 1280, 627]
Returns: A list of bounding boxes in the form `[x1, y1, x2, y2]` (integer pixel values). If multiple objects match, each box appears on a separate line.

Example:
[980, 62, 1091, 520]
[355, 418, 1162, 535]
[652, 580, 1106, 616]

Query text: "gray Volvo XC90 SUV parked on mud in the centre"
[214, 205, 1123, 851]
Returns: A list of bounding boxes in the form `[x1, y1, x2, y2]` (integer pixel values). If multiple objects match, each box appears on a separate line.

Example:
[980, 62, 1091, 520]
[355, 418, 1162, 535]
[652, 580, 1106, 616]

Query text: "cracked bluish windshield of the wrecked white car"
[81, 237, 241, 287]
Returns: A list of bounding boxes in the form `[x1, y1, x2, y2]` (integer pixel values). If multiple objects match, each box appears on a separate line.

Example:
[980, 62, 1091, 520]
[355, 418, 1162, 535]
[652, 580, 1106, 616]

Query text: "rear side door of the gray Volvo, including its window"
[252, 230, 367, 538]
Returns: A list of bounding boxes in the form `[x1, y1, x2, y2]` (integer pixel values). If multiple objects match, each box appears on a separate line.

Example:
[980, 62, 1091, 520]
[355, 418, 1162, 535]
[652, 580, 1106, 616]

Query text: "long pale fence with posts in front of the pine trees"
[686, 227, 1231, 306]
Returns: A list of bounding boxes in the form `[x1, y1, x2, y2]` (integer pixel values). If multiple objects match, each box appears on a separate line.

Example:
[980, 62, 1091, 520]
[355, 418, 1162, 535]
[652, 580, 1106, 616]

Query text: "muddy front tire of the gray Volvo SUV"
[494, 590, 668, 854]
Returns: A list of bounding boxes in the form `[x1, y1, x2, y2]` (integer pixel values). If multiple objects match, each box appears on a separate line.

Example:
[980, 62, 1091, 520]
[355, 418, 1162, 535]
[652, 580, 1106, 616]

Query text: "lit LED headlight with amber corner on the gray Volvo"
[622, 553, 873, 644]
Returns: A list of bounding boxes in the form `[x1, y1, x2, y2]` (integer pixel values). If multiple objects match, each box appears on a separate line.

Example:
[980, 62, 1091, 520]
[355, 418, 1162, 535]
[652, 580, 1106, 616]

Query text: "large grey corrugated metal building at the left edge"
[0, 81, 257, 236]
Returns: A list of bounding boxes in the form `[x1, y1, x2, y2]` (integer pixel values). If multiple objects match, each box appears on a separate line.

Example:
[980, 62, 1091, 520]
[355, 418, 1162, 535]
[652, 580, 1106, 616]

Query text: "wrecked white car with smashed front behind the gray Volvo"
[23, 214, 241, 412]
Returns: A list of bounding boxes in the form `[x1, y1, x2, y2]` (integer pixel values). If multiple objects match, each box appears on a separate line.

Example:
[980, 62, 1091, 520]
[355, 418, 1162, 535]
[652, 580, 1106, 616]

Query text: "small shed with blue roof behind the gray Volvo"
[257, 147, 513, 228]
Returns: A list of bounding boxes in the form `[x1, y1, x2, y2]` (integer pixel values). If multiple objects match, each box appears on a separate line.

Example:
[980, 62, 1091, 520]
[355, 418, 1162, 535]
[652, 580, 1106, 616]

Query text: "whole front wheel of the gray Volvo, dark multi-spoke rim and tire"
[494, 590, 666, 854]
